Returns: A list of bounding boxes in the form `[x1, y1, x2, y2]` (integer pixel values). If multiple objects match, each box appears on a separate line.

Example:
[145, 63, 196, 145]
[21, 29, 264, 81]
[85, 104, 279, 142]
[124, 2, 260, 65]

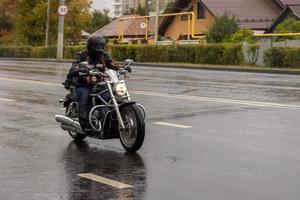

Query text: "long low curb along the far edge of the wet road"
[0, 57, 300, 75]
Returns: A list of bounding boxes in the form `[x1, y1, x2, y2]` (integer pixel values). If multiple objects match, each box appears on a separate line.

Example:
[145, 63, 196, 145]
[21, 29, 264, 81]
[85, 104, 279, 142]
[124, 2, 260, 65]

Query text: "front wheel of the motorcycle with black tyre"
[119, 105, 145, 152]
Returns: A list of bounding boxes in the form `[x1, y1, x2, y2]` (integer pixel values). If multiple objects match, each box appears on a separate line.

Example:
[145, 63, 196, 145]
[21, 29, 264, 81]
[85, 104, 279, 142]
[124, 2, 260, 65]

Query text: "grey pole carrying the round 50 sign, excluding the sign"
[56, 0, 65, 60]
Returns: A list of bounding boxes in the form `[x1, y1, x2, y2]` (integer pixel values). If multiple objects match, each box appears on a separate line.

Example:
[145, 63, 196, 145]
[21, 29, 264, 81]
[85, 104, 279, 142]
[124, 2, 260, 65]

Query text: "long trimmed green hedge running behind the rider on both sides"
[0, 44, 243, 65]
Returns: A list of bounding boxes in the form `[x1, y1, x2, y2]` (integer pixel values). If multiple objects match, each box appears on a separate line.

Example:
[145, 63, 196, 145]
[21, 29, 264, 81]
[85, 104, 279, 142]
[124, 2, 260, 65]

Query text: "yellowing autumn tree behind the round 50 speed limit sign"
[14, 0, 91, 46]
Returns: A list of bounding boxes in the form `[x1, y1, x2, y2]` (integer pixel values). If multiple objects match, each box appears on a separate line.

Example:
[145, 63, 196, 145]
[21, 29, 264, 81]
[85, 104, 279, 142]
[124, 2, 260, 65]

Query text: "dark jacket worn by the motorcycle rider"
[66, 50, 119, 87]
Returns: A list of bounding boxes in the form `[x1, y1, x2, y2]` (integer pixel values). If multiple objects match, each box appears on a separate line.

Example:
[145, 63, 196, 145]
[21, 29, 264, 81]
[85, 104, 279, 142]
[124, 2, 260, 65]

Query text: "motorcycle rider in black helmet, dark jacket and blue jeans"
[67, 36, 124, 132]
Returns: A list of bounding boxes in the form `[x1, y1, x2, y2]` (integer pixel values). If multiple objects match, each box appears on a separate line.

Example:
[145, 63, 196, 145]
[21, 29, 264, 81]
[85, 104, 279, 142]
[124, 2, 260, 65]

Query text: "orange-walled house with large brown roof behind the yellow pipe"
[159, 0, 288, 39]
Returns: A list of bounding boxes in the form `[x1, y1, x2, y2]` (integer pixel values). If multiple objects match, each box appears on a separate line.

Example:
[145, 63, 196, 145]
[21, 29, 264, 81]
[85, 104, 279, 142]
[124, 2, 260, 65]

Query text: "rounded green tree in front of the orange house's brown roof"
[206, 13, 239, 42]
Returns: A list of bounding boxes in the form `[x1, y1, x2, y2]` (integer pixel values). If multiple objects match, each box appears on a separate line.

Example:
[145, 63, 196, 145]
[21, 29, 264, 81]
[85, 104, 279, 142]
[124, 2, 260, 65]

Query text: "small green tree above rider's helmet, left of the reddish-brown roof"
[86, 9, 112, 33]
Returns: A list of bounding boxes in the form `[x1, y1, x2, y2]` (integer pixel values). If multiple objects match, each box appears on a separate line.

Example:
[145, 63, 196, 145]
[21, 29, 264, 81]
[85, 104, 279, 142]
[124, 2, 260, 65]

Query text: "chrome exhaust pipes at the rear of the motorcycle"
[55, 115, 84, 134]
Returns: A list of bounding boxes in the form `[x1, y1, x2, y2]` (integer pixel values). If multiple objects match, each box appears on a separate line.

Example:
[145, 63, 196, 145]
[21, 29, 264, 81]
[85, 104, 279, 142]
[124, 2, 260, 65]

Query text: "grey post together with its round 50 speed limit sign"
[56, 0, 68, 60]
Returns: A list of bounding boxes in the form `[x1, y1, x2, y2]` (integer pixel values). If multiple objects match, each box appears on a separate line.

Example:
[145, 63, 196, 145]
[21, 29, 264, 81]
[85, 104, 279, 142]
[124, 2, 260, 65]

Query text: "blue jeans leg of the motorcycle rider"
[75, 86, 92, 130]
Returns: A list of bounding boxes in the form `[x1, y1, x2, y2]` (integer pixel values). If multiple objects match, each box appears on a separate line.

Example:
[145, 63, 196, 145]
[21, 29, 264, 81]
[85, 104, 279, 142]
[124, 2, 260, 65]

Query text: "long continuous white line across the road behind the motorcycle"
[0, 77, 300, 110]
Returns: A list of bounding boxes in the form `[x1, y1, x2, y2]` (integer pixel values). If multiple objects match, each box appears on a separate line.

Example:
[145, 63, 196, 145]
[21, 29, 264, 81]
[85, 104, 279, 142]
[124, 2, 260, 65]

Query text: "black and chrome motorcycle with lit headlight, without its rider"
[55, 59, 146, 152]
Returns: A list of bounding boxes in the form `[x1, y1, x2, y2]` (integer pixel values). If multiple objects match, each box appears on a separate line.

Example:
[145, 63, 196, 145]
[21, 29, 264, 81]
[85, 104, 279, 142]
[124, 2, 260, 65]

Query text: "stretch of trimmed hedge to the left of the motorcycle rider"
[0, 46, 85, 59]
